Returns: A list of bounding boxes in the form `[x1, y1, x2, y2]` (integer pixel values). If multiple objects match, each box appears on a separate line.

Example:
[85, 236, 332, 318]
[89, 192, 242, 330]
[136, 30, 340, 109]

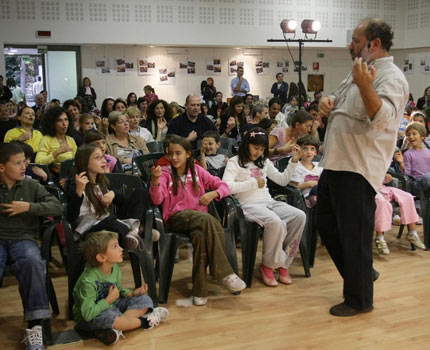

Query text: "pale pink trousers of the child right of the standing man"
[375, 186, 418, 232]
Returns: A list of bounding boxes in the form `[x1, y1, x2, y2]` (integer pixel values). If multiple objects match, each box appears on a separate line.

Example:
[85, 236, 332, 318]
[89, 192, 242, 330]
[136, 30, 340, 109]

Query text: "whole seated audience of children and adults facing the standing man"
[0, 78, 430, 350]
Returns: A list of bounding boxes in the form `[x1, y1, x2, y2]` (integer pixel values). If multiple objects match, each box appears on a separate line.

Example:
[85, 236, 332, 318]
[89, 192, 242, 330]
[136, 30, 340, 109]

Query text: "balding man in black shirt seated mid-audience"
[167, 95, 216, 148]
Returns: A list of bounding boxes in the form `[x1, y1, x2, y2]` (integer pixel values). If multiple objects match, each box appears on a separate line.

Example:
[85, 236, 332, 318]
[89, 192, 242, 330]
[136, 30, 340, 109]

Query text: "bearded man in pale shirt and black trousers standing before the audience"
[317, 19, 409, 316]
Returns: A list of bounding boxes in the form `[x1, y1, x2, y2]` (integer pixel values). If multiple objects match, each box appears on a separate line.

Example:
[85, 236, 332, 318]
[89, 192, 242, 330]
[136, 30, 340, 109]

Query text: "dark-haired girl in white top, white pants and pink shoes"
[223, 128, 306, 287]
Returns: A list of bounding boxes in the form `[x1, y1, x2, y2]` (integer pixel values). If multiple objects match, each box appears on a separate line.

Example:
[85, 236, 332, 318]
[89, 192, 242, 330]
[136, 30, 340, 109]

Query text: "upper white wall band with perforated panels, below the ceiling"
[0, 0, 406, 48]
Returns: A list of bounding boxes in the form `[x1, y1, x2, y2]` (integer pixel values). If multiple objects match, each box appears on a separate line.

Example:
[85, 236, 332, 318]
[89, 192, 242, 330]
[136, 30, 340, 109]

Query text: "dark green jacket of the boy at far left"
[0, 179, 63, 240]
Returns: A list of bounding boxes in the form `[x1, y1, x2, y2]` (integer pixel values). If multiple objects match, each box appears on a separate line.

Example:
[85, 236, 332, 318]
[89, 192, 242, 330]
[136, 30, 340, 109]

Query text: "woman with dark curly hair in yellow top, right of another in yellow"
[36, 107, 77, 172]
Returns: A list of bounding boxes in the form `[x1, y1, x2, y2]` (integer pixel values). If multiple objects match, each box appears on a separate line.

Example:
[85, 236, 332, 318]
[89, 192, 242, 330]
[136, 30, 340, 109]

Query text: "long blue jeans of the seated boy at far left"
[0, 239, 51, 322]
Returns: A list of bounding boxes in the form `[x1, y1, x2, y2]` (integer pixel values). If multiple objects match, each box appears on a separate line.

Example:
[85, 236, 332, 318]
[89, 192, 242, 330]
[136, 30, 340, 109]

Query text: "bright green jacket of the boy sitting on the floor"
[73, 264, 131, 323]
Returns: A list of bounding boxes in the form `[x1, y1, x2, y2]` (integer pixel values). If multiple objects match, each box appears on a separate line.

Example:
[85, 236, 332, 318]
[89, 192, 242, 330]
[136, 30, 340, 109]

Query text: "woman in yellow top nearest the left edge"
[4, 106, 43, 153]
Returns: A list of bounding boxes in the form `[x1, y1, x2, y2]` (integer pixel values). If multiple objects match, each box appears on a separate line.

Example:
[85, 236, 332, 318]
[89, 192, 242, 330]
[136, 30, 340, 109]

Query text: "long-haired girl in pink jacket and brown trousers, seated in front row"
[149, 136, 246, 306]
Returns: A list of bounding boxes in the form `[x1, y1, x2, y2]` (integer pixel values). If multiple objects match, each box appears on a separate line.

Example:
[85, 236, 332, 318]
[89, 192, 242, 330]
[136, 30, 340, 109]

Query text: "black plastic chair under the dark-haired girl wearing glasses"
[106, 174, 158, 305]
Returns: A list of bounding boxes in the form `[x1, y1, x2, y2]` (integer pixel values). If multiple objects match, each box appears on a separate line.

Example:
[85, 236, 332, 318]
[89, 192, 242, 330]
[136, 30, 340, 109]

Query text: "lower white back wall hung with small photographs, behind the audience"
[81, 45, 351, 106]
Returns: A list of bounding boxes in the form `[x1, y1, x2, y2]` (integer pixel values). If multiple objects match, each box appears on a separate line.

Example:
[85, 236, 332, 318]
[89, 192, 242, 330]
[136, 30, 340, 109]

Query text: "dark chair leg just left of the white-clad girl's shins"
[240, 222, 260, 288]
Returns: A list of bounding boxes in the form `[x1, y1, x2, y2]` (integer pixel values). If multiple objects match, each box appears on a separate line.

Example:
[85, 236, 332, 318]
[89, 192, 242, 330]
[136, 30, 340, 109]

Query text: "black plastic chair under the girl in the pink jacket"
[154, 197, 240, 304]
